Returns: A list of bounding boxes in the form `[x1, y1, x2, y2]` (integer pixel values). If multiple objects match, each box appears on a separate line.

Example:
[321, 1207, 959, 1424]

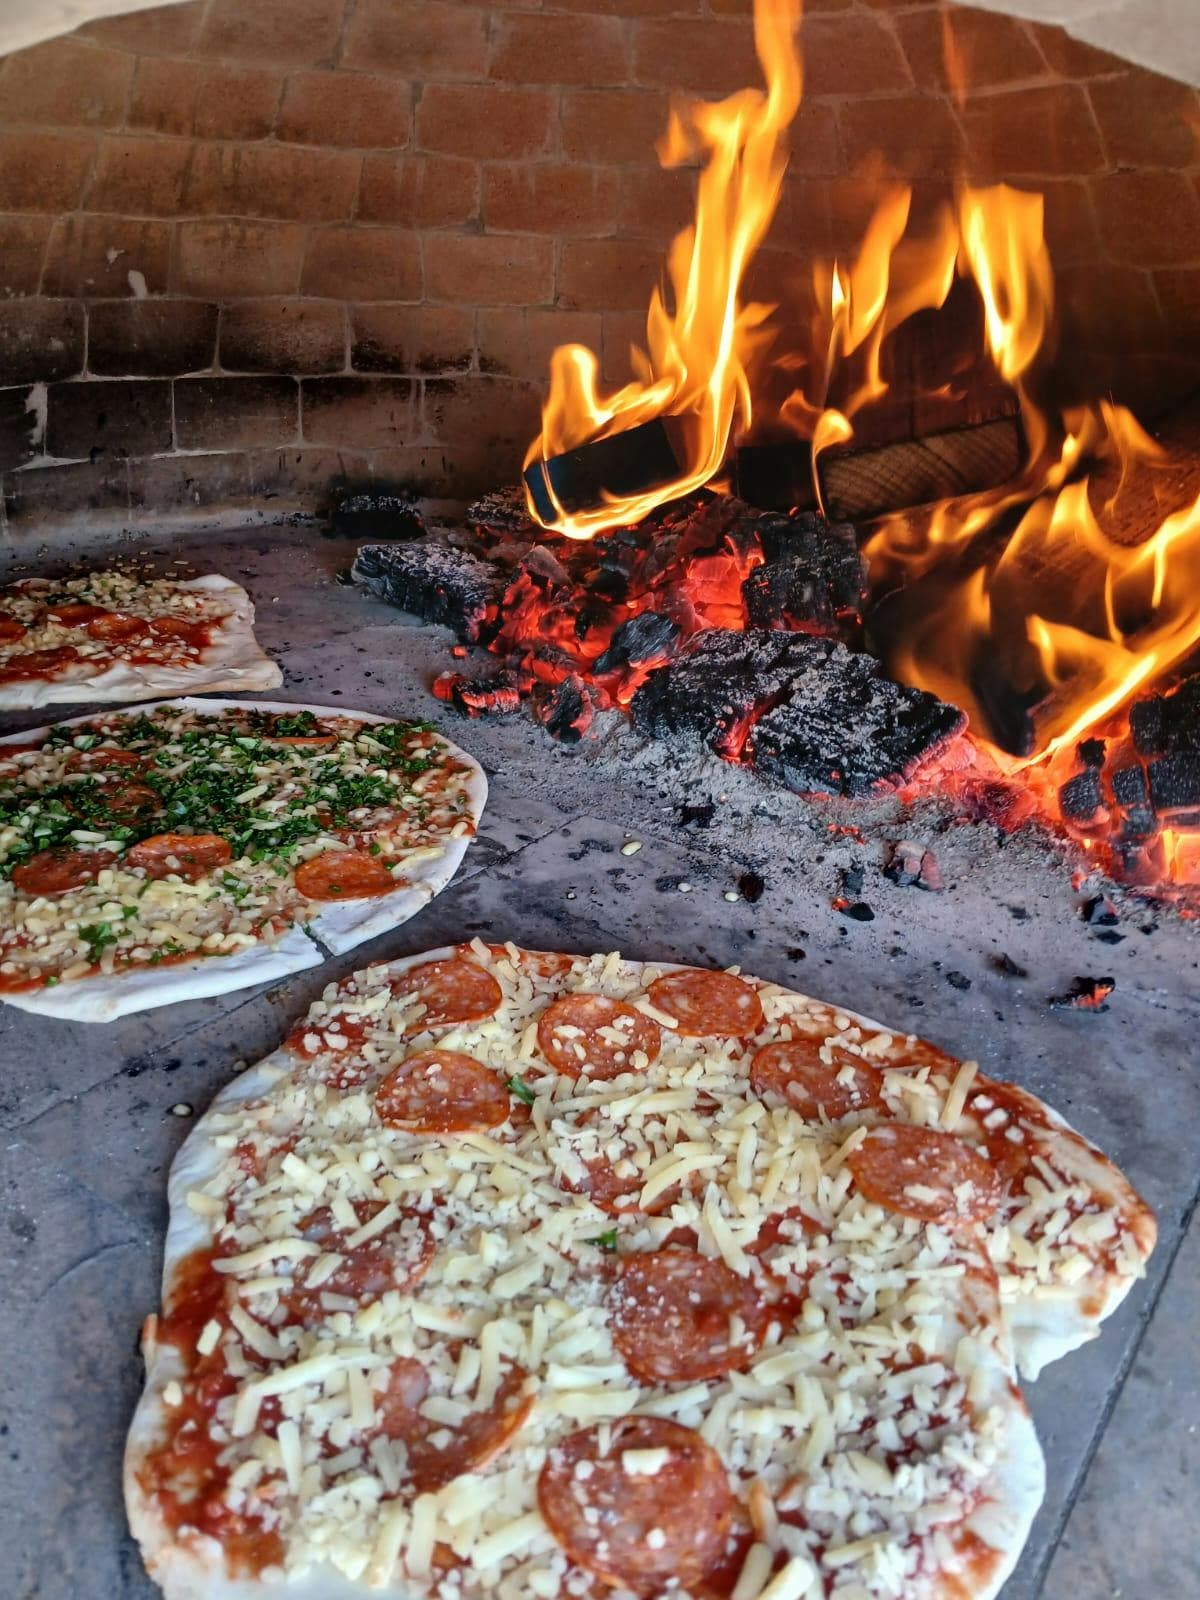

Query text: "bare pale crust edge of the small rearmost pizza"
[0, 573, 283, 710]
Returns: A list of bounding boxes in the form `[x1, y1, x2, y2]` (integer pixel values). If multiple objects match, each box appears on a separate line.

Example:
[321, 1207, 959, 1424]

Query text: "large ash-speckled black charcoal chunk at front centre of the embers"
[746, 634, 966, 795]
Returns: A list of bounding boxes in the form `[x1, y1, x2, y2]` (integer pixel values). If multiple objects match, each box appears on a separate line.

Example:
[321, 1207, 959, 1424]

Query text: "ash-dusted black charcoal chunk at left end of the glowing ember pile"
[350, 539, 506, 642]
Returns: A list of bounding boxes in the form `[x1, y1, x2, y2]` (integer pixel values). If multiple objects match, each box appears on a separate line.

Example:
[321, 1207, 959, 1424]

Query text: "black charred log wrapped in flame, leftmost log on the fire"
[525, 418, 680, 523]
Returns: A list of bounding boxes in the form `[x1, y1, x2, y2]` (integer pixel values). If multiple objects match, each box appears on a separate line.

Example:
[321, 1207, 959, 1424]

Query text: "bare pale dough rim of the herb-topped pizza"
[0, 696, 488, 1022]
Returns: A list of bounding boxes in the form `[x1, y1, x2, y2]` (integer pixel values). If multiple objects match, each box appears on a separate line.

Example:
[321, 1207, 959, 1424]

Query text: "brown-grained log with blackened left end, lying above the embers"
[736, 416, 1024, 522]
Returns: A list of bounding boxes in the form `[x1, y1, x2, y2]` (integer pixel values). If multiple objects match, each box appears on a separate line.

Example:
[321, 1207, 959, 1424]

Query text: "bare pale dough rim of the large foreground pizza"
[125, 946, 1081, 1600]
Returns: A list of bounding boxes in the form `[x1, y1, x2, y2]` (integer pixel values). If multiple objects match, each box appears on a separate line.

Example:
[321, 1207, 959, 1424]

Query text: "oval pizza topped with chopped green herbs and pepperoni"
[0, 701, 486, 1021]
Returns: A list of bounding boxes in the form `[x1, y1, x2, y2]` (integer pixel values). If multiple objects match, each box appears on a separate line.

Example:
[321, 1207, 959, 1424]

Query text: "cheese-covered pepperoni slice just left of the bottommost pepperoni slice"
[376, 1357, 533, 1494]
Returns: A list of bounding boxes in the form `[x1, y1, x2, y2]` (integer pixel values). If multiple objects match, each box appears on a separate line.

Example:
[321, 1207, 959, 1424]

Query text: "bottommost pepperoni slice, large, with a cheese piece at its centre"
[538, 1416, 734, 1595]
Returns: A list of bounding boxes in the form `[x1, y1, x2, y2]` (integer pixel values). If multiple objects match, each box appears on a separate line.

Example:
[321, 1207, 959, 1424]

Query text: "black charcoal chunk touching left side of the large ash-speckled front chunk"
[629, 627, 809, 754]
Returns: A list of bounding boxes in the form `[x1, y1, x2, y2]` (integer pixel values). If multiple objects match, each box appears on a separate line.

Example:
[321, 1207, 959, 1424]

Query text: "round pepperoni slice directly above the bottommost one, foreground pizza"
[610, 1248, 766, 1384]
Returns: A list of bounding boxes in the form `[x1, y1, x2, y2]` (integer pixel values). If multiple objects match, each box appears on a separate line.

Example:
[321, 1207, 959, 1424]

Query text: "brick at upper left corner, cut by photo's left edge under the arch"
[0, 38, 133, 128]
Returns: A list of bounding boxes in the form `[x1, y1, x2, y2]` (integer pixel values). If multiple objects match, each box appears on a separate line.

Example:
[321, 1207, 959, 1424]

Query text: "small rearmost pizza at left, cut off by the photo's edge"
[0, 570, 283, 710]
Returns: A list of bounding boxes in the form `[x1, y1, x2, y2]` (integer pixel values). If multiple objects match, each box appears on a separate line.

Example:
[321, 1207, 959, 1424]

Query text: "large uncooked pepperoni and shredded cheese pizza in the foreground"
[126, 941, 1154, 1600]
